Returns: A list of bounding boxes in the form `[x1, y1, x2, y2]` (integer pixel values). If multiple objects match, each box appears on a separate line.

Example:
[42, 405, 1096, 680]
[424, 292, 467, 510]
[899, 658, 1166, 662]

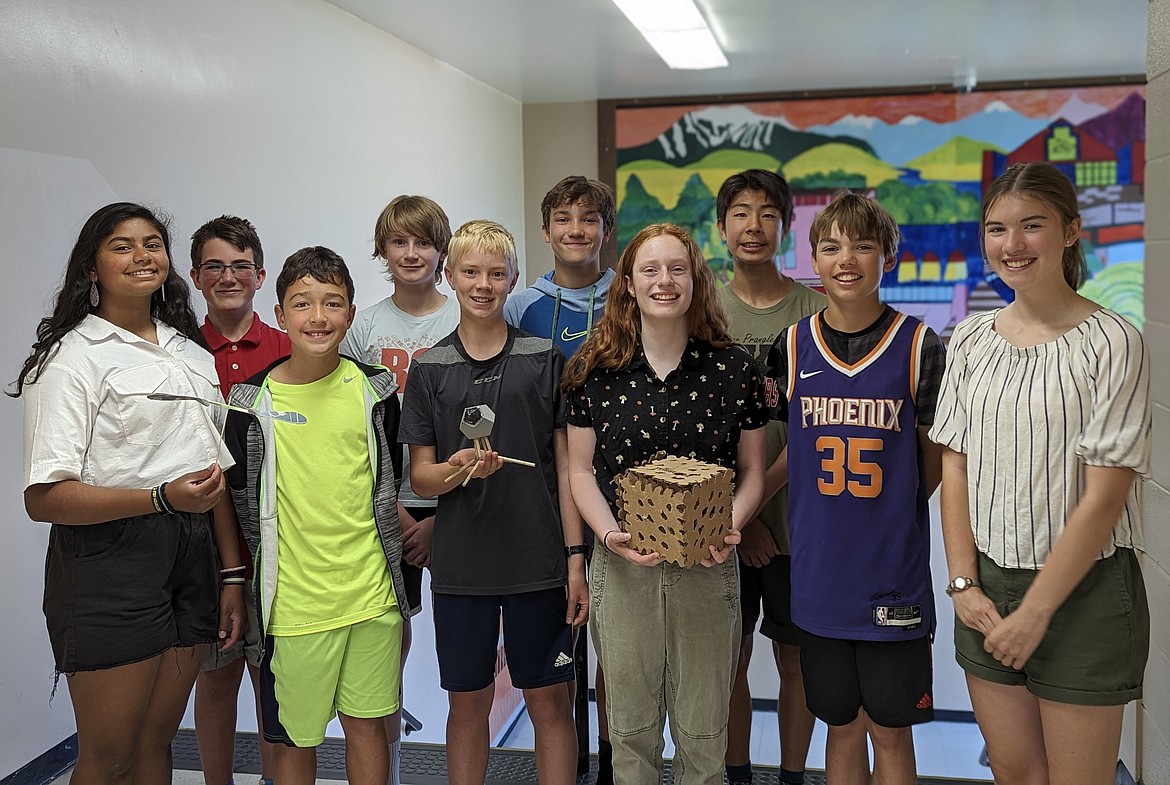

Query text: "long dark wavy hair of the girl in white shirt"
[8, 201, 207, 398]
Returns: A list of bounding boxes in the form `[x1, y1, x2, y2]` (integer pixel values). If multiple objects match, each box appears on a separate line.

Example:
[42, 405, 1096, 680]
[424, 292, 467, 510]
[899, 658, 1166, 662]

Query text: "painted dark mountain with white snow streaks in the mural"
[618, 105, 873, 166]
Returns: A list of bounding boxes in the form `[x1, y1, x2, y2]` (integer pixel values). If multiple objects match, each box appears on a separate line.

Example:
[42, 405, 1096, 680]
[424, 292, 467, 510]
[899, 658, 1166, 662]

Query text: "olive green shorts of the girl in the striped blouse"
[955, 548, 1150, 705]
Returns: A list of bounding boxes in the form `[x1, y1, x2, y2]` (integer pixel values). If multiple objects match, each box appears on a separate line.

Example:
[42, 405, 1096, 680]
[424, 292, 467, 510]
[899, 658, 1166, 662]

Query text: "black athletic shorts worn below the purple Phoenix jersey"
[800, 629, 935, 728]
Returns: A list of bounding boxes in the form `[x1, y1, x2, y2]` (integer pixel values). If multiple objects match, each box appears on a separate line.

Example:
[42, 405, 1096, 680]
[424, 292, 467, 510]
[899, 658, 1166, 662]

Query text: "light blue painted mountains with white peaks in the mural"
[807, 101, 1048, 164]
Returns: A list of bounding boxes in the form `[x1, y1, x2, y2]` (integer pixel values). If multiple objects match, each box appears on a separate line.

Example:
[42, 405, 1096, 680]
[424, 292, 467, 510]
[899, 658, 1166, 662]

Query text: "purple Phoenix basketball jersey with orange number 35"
[787, 314, 935, 640]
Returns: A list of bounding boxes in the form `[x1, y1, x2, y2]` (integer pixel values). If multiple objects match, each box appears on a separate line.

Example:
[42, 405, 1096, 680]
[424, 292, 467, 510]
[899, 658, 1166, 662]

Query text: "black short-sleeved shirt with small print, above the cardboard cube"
[569, 338, 768, 510]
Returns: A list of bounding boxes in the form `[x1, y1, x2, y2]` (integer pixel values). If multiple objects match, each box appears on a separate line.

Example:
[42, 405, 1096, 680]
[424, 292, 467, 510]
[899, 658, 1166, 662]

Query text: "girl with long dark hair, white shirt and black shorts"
[15, 202, 243, 783]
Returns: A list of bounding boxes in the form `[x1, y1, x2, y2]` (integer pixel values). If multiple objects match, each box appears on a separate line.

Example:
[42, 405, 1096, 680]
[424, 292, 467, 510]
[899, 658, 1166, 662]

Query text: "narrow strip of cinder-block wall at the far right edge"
[1141, 0, 1170, 785]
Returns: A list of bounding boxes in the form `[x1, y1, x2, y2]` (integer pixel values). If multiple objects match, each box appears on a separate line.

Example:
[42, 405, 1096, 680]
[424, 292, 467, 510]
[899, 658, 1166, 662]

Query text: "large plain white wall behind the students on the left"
[0, 0, 524, 778]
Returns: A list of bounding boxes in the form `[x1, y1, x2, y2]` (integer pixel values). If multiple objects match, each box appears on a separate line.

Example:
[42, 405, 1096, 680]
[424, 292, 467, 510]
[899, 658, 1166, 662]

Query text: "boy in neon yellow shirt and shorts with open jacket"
[226, 247, 413, 785]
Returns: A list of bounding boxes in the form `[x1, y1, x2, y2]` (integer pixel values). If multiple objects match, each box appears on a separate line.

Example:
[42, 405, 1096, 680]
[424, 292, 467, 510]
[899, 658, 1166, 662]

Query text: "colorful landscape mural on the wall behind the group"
[615, 84, 1145, 336]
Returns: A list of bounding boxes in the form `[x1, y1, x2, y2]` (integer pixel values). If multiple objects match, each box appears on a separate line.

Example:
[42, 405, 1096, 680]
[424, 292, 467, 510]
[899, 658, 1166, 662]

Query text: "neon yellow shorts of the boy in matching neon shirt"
[261, 607, 402, 746]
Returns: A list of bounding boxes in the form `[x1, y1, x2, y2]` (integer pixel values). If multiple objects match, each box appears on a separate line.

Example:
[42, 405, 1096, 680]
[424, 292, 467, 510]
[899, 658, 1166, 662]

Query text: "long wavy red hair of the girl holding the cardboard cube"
[560, 223, 731, 390]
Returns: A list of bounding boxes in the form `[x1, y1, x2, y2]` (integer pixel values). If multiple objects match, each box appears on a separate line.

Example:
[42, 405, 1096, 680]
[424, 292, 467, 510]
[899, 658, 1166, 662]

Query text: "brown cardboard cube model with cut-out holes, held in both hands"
[618, 455, 732, 567]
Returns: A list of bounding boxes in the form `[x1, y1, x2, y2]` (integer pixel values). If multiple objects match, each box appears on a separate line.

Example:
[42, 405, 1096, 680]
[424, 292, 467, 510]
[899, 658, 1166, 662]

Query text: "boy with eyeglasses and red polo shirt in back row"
[191, 215, 290, 785]
